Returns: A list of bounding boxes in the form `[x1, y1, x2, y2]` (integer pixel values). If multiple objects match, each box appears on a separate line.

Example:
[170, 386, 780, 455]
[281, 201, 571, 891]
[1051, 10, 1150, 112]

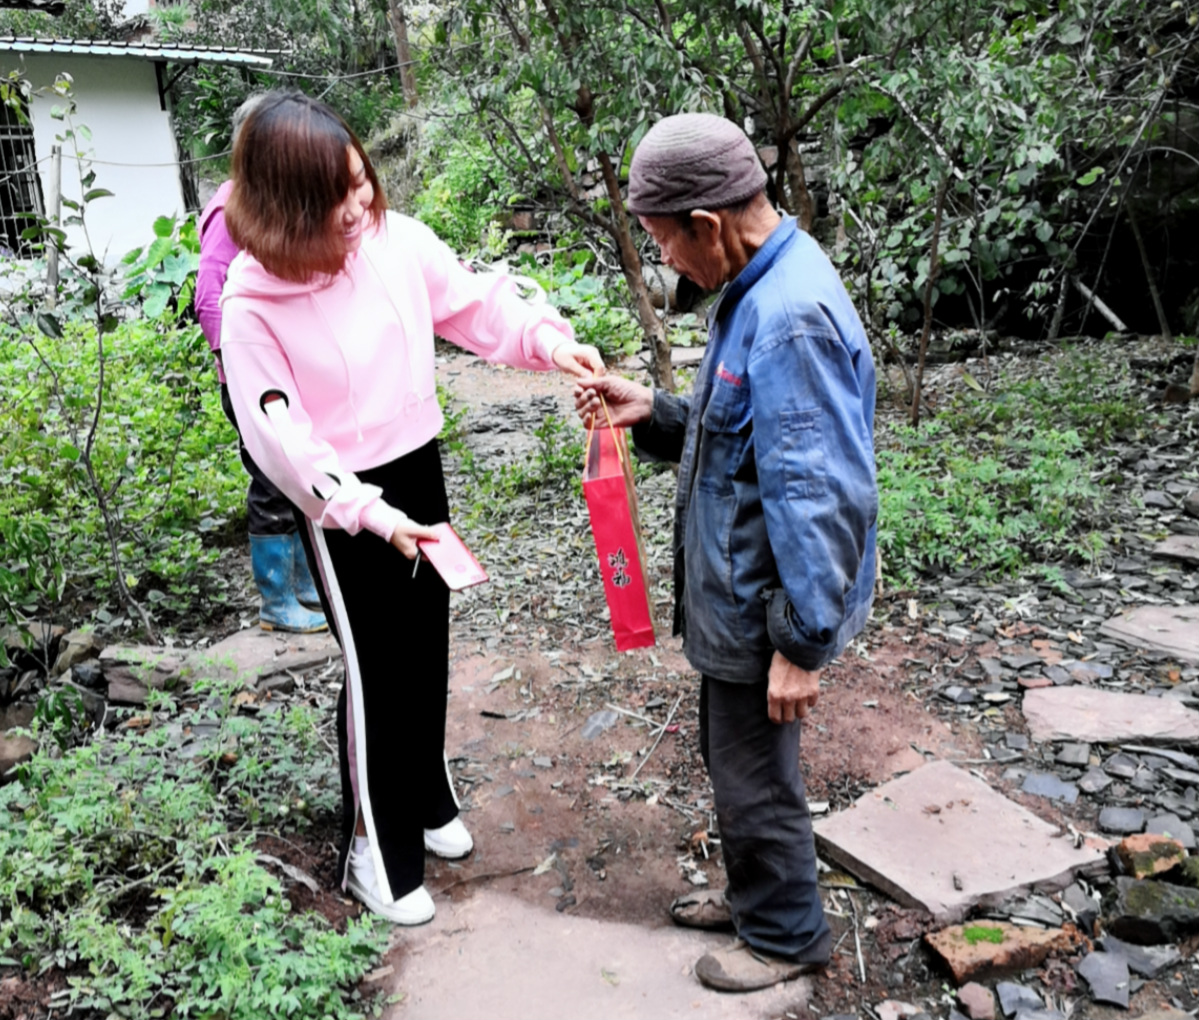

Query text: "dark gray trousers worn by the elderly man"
[699, 676, 832, 962]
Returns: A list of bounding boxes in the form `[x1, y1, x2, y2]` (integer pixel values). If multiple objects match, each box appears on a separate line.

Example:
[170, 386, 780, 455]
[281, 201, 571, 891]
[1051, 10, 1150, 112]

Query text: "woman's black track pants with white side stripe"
[293, 441, 458, 900]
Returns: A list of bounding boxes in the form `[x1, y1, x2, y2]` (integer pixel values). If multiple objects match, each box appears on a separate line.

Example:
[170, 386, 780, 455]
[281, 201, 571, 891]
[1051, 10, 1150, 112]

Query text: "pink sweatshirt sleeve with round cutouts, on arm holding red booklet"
[223, 298, 405, 541]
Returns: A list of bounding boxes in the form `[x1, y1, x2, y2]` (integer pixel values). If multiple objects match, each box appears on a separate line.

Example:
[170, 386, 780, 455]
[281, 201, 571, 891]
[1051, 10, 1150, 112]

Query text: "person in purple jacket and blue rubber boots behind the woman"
[195, 96, 329, 634]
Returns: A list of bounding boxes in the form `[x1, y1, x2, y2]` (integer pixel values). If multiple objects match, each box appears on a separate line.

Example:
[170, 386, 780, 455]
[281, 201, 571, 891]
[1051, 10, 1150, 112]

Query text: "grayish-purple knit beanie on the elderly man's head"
[628, 114, 766, 216]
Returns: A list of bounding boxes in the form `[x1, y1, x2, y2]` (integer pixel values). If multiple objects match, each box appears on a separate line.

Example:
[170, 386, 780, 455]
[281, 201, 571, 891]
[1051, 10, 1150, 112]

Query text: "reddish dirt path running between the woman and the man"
[354, 345, 977, 1018]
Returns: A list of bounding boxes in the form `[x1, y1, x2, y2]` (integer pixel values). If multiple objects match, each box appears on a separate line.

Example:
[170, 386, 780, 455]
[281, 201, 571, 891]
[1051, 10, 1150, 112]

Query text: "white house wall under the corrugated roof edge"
[15, 54, 185, 264]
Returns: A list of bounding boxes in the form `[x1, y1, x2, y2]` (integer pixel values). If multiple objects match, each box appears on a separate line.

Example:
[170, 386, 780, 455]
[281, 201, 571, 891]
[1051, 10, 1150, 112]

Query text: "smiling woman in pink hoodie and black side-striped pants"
[221, 92, 603, 924]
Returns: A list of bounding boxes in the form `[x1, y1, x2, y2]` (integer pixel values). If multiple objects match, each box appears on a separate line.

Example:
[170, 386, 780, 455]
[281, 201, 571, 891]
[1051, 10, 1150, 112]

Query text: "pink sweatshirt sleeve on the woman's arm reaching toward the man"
[410, 221, 574, 372]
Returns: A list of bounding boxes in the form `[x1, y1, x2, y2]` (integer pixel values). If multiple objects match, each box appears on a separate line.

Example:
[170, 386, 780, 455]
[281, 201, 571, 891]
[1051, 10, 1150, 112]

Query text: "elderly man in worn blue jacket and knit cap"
[576, 114, 878, 991]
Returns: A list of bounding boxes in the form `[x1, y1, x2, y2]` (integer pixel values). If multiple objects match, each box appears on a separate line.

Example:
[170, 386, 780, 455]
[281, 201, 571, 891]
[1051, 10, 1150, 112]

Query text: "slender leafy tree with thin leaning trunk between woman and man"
[428, 0, 703, 388]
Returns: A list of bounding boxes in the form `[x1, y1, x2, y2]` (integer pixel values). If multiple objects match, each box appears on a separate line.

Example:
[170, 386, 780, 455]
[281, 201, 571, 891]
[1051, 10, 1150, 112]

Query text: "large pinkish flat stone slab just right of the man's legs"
[815, 761, 1105, 923]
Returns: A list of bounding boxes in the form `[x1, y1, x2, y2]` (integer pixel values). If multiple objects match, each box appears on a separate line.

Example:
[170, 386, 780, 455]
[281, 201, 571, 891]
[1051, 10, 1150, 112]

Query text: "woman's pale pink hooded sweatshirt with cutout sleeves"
[221, 212, 573, 539]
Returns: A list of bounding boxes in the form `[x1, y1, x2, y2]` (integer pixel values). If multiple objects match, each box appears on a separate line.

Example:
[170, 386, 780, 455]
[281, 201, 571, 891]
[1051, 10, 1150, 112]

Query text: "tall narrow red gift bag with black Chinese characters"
[583, 406, 655, 652]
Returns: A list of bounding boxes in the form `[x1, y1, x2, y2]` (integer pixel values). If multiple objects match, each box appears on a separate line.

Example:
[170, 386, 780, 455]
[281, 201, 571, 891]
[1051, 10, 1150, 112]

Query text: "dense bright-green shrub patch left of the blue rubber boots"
[0, 319, 245, 609]
